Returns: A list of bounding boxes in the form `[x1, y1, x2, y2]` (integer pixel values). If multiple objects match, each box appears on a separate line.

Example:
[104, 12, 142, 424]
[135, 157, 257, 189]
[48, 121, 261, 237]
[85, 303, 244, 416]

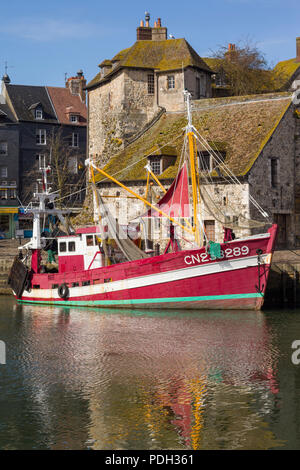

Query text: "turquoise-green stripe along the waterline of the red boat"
[18, 293, 264, 307]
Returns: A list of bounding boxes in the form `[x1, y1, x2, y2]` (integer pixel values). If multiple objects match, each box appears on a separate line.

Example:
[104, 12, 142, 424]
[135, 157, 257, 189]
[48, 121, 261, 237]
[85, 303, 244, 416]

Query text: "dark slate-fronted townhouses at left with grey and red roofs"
[0, 71, 87, 238]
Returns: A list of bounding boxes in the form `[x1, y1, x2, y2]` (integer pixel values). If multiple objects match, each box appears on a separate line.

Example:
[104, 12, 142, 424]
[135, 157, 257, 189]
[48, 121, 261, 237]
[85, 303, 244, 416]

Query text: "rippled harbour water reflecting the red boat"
[0, 296, 300, 450]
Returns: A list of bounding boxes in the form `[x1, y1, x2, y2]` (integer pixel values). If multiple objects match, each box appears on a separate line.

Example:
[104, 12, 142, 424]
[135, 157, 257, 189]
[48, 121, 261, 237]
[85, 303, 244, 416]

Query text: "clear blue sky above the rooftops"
[0, 0, 300, 86]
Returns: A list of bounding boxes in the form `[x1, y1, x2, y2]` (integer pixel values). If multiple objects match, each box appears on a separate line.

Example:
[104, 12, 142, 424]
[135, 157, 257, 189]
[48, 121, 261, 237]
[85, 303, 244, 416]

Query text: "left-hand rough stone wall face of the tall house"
[89, 69, 158, 164]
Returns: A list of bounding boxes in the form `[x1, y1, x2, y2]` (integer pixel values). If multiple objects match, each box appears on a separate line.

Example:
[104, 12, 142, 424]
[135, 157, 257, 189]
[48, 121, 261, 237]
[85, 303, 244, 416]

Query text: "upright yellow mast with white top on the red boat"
[183, 90, 200, 245]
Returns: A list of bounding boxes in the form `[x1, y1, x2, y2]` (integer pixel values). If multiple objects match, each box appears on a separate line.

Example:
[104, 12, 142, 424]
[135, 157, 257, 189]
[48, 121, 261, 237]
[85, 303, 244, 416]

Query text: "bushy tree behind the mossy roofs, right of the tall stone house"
[211, 40, 279, 95]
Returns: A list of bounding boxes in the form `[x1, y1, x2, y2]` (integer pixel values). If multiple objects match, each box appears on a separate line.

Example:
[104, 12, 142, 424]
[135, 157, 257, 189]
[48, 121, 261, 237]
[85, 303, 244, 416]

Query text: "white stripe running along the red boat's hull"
[23, 255, 271, 300]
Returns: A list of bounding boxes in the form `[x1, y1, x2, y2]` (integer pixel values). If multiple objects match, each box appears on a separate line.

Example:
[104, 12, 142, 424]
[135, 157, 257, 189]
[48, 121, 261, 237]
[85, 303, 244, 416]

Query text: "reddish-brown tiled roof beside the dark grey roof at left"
[47, 87, 87, 126]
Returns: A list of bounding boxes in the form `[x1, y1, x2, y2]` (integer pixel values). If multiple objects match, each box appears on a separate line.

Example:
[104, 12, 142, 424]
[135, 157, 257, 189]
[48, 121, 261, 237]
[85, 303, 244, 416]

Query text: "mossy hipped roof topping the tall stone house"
[86, 39, 213, 89]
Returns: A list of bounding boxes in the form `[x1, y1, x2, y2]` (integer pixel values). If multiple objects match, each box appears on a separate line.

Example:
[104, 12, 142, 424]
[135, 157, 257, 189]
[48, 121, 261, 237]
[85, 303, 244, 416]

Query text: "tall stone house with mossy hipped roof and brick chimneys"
[87, 15, 212, 163]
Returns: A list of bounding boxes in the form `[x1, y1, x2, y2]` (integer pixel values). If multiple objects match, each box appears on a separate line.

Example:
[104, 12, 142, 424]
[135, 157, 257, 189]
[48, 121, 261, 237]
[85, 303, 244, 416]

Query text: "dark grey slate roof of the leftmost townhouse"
[6, 84, 57, 123]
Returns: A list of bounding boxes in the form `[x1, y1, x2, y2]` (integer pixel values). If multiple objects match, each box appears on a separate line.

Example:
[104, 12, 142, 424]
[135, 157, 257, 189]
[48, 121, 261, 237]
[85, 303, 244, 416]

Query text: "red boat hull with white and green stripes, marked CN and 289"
[18, 225, 277, 310]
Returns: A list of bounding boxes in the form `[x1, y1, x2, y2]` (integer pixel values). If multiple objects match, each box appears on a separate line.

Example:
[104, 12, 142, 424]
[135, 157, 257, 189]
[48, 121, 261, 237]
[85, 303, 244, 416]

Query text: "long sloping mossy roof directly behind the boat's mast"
[97, 93, 291, 182]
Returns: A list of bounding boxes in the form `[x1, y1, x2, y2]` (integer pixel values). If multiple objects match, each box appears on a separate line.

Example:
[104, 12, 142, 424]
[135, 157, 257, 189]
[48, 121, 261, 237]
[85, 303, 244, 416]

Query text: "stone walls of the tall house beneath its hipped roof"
[88, 68, 211, 164]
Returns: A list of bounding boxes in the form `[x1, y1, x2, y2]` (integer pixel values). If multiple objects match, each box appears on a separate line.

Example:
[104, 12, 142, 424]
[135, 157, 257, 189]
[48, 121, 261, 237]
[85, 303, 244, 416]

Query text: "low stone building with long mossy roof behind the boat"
[89, 93, 300, 252]
